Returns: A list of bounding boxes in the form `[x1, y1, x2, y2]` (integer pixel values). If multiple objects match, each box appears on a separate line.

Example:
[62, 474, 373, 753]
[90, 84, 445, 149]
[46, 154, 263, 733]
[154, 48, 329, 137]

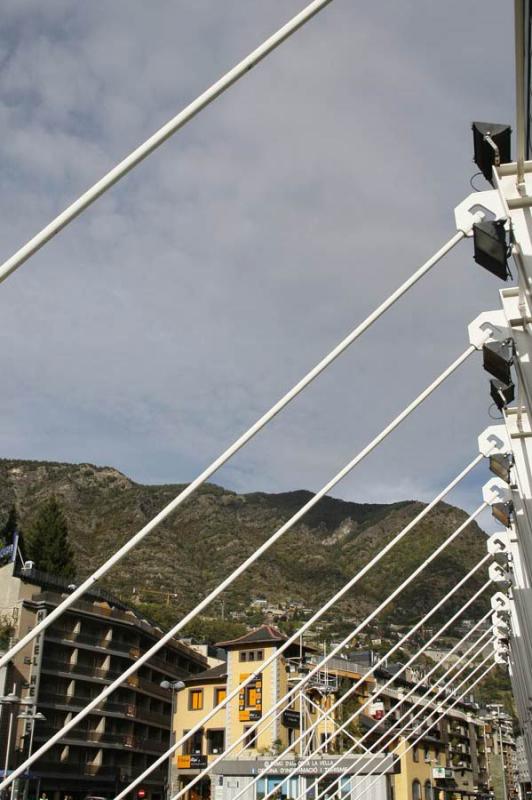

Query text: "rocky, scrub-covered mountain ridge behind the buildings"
[0, 460, 485, 622]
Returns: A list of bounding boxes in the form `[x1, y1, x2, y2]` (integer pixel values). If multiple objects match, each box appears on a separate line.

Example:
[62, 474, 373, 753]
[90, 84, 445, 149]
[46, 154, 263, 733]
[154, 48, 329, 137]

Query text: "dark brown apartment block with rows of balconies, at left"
[0, 562, 208, 800]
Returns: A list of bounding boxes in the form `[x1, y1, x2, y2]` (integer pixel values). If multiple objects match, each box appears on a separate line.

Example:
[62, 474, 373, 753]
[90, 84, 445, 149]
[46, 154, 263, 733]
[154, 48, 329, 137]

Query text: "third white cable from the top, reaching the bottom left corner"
[0, 346, 475, 790]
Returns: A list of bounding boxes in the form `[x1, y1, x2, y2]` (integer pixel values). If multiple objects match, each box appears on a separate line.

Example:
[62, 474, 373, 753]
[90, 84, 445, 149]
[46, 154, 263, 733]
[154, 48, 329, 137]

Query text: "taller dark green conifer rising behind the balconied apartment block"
[26, 497, 75, 578]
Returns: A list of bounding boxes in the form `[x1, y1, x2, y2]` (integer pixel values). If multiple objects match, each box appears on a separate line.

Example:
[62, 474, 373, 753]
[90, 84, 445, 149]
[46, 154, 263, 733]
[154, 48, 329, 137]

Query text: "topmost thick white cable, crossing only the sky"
[0, 0, 338, 282]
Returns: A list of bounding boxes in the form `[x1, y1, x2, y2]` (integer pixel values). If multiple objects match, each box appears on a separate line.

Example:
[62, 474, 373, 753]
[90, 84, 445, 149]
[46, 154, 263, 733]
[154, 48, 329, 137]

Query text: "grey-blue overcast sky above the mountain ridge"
[0, 0, 514, 532]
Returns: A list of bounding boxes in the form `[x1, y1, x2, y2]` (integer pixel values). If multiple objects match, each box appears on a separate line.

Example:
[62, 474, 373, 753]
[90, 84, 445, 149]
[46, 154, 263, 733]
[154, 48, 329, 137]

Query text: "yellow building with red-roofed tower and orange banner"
[171, 625, 393, 800]
